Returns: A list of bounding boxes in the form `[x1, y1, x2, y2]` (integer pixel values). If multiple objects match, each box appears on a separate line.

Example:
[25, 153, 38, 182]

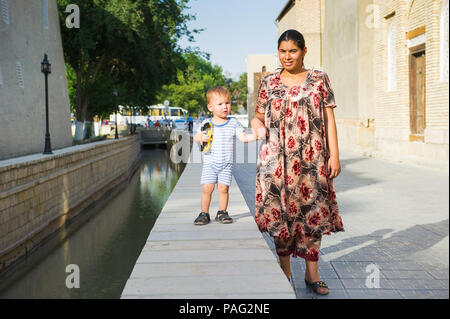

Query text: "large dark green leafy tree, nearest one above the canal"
[58, 0, 198, 139]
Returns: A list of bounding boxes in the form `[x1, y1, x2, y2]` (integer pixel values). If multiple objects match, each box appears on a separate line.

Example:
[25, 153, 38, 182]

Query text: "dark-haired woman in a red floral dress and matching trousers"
[251, 30, 344, 295]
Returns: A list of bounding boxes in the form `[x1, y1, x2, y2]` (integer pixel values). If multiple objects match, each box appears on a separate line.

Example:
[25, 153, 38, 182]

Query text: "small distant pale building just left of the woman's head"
[247, 54, 279, 122]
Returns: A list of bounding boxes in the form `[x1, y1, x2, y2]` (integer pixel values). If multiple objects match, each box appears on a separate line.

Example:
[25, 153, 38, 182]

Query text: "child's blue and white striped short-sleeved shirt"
[197, 118, 245, 164]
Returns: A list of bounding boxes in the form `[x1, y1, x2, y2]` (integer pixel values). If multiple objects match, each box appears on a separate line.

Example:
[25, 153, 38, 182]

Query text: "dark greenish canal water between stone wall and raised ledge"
[0, 148, 185, 298]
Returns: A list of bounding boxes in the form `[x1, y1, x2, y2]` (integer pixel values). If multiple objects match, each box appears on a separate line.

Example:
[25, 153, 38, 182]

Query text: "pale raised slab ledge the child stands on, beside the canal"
[122, 147, 295, 299]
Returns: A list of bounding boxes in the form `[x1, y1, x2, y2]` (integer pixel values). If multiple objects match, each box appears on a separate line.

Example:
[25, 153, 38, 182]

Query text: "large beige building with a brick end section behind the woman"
[277, 0, 449, 163]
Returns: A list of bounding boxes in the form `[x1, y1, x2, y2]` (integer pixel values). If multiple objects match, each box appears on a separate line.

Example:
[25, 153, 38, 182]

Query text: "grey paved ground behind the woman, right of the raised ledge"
[234, 141, 449, 299]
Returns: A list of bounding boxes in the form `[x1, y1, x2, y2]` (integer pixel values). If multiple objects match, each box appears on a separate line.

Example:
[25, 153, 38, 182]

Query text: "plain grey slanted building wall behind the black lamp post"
[0, 0, 72, 160]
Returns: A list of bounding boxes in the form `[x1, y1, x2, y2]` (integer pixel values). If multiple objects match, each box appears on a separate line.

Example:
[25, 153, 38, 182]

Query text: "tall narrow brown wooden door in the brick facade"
[410, 48, 426, 141]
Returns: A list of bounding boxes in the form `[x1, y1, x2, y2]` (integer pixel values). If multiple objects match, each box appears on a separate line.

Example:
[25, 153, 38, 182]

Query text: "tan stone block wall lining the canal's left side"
[0, 135, 141, 272]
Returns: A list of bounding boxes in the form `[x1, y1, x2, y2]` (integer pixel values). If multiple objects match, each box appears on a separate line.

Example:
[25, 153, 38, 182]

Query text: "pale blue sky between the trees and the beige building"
[179, 0, 287, 79]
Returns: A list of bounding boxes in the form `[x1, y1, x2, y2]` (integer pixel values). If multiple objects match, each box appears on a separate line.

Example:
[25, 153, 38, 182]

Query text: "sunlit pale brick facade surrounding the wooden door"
[374, 0, 449, 161]
